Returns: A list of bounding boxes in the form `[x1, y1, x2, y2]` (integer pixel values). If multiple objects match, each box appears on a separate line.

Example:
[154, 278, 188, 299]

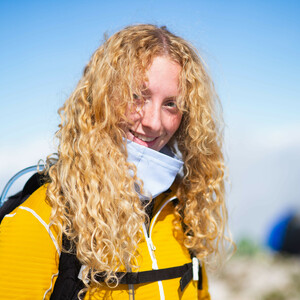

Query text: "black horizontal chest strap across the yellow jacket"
[96, 263, 202, 291]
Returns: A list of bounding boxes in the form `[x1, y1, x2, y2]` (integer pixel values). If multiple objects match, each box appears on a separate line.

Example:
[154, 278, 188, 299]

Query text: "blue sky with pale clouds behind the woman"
[0, 0, 300, 240]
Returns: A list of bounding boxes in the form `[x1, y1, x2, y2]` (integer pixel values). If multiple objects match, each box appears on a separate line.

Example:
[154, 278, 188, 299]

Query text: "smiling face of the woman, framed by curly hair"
[125, 56, 182, 151]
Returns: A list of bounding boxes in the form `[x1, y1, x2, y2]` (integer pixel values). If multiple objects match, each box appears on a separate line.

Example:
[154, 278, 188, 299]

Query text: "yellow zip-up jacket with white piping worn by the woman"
[0, 186, 210, 300]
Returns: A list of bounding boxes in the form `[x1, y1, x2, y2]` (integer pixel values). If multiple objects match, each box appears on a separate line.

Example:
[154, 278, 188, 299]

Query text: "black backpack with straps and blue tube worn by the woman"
[0, 166, 202, 300]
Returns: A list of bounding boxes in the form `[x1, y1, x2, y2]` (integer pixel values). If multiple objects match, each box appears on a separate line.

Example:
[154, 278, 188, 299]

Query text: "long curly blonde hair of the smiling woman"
[47, 25, 227, 284]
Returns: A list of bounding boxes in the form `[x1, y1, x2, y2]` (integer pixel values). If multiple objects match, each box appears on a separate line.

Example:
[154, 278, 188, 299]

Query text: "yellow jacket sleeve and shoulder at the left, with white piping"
[0, 186, 60, 299]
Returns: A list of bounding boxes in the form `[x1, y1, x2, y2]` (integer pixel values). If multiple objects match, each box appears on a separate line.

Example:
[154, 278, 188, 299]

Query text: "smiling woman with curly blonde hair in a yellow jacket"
[0, 25, 230, 299]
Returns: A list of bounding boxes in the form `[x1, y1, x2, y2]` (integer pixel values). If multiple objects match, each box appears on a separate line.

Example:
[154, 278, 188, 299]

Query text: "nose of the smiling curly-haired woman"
[141, 103, 162, 133]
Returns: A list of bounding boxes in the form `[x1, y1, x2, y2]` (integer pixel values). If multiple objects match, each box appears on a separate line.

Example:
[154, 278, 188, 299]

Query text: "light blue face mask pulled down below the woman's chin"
[127, 140, 183, 199]
